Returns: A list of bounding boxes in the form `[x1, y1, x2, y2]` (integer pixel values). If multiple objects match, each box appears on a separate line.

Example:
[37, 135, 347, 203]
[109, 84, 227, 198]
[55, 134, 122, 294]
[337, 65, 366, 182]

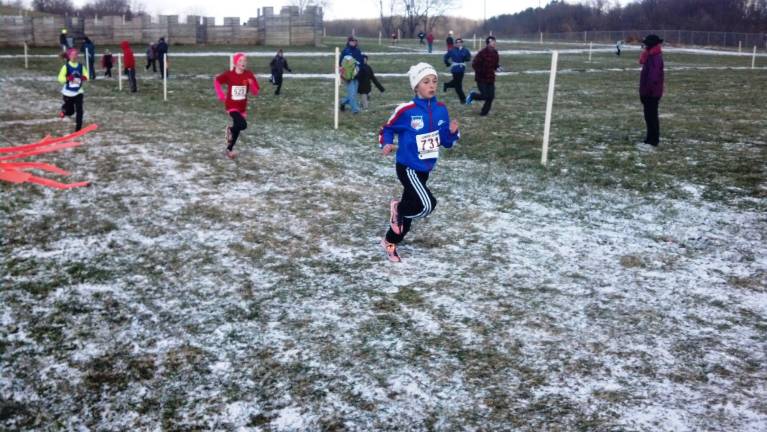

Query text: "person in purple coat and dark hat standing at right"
[639, 34, 663, 147]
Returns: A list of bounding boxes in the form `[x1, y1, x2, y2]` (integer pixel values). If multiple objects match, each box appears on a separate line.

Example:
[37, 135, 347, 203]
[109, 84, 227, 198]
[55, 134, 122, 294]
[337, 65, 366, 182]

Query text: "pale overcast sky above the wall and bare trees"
[46, 0, 612, 23]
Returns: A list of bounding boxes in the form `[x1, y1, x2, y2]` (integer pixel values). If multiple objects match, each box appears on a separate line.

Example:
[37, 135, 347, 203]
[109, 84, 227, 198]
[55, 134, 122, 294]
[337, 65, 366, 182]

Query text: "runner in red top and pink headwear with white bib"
[213, 52, 259, 159]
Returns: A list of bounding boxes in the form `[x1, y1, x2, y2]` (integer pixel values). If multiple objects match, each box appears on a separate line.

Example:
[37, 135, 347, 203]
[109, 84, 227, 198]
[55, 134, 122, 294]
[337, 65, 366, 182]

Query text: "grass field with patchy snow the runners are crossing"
[0, 42, 767, 431]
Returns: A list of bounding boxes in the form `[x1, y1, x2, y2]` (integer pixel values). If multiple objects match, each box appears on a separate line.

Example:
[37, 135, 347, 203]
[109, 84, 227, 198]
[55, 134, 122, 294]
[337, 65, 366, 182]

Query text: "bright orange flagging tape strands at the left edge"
[0, 124, 98, 189]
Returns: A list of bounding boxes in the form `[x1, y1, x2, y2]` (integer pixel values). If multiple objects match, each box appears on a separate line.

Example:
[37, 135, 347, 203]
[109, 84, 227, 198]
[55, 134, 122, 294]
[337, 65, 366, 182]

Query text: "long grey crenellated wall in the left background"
[0, 6, 323, 47]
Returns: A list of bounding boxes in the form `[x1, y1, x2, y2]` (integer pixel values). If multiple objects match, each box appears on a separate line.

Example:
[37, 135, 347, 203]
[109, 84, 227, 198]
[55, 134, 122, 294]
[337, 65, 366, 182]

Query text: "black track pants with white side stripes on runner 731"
[386, 163, 437, 244]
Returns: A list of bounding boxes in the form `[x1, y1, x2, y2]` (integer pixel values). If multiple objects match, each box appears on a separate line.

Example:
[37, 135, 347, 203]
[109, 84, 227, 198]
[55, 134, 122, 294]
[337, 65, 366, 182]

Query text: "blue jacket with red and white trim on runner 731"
[378, 97, 461, 172]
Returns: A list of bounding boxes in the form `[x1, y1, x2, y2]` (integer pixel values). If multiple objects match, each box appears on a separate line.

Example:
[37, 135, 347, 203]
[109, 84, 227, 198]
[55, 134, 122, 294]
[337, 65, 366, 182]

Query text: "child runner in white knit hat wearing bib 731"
[378, 63, 460, 262]
